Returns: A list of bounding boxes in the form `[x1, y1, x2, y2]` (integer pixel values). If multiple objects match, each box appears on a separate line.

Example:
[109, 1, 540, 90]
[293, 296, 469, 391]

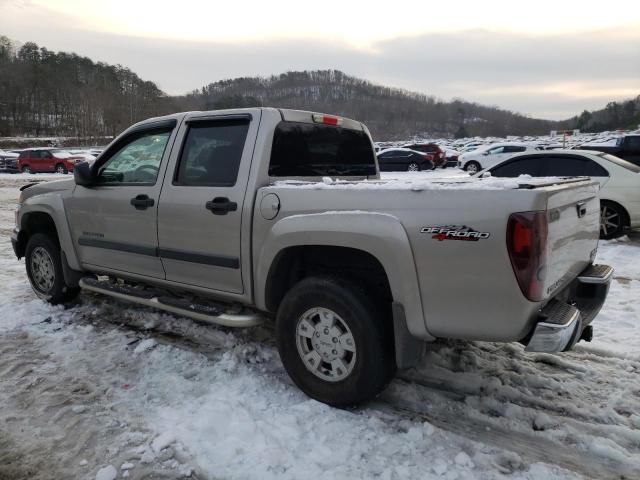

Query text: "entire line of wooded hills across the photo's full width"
[0, 36, 640, 140]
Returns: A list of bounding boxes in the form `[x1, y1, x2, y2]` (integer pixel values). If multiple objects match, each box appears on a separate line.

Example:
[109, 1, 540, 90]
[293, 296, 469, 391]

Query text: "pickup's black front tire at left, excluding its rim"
[25, 233, 80, 305]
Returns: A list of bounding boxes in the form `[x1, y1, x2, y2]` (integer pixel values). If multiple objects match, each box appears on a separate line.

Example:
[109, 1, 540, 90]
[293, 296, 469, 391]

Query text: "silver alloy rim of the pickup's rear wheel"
[296, 307, 357, 382]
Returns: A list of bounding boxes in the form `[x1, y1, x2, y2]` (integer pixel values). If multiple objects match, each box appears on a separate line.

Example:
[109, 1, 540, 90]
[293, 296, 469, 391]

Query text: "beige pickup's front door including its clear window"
[68, 120, 176, 278]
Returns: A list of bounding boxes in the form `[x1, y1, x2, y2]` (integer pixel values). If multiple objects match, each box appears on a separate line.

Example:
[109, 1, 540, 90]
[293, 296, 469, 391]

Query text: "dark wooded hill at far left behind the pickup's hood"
[0, 36, 175, 137]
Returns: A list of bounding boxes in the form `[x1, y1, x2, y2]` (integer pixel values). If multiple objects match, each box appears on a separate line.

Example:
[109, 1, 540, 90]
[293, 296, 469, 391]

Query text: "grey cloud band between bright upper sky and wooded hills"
[0, 0, 640, 118]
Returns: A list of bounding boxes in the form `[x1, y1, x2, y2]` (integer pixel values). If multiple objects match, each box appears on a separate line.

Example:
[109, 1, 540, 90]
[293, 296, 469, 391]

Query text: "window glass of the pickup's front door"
[97, 129, 172, 185]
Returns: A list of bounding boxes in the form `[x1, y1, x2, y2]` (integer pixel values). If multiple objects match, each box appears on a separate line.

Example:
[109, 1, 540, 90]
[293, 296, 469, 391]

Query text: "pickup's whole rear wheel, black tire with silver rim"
[276, 277, 396, 406]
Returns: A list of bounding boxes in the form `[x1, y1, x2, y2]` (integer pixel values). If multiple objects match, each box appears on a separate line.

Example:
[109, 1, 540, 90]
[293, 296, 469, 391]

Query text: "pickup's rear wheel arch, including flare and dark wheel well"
[254, 212, 434, 340]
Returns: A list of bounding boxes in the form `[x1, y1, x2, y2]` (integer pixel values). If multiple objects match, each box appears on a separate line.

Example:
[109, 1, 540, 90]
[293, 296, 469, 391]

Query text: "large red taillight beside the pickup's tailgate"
[507, 212, 548, 302]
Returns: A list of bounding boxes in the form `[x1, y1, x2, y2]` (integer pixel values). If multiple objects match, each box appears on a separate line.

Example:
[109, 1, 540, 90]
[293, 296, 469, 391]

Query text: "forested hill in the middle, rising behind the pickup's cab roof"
[180, 70, 559, 139]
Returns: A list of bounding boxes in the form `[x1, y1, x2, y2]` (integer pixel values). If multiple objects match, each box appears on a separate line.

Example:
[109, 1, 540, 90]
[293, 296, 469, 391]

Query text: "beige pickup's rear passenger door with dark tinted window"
[158, 109, 261, 294]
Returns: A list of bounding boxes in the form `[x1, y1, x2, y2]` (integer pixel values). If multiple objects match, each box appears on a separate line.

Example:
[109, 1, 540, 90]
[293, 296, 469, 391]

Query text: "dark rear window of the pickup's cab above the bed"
[269, 122, 376, 177]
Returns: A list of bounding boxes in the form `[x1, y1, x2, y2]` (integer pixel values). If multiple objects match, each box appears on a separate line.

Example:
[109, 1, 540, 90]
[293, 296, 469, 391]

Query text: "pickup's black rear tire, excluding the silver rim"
[276, 277, 396, 406]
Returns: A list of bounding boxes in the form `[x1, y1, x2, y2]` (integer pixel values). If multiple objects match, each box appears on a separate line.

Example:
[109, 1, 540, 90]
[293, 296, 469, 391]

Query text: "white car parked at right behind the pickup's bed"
[479, 150, 640, 239]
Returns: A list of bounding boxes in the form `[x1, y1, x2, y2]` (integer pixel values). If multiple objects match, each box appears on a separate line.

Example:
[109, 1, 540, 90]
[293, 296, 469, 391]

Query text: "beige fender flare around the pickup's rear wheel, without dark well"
[255, 211, 434, 341]
